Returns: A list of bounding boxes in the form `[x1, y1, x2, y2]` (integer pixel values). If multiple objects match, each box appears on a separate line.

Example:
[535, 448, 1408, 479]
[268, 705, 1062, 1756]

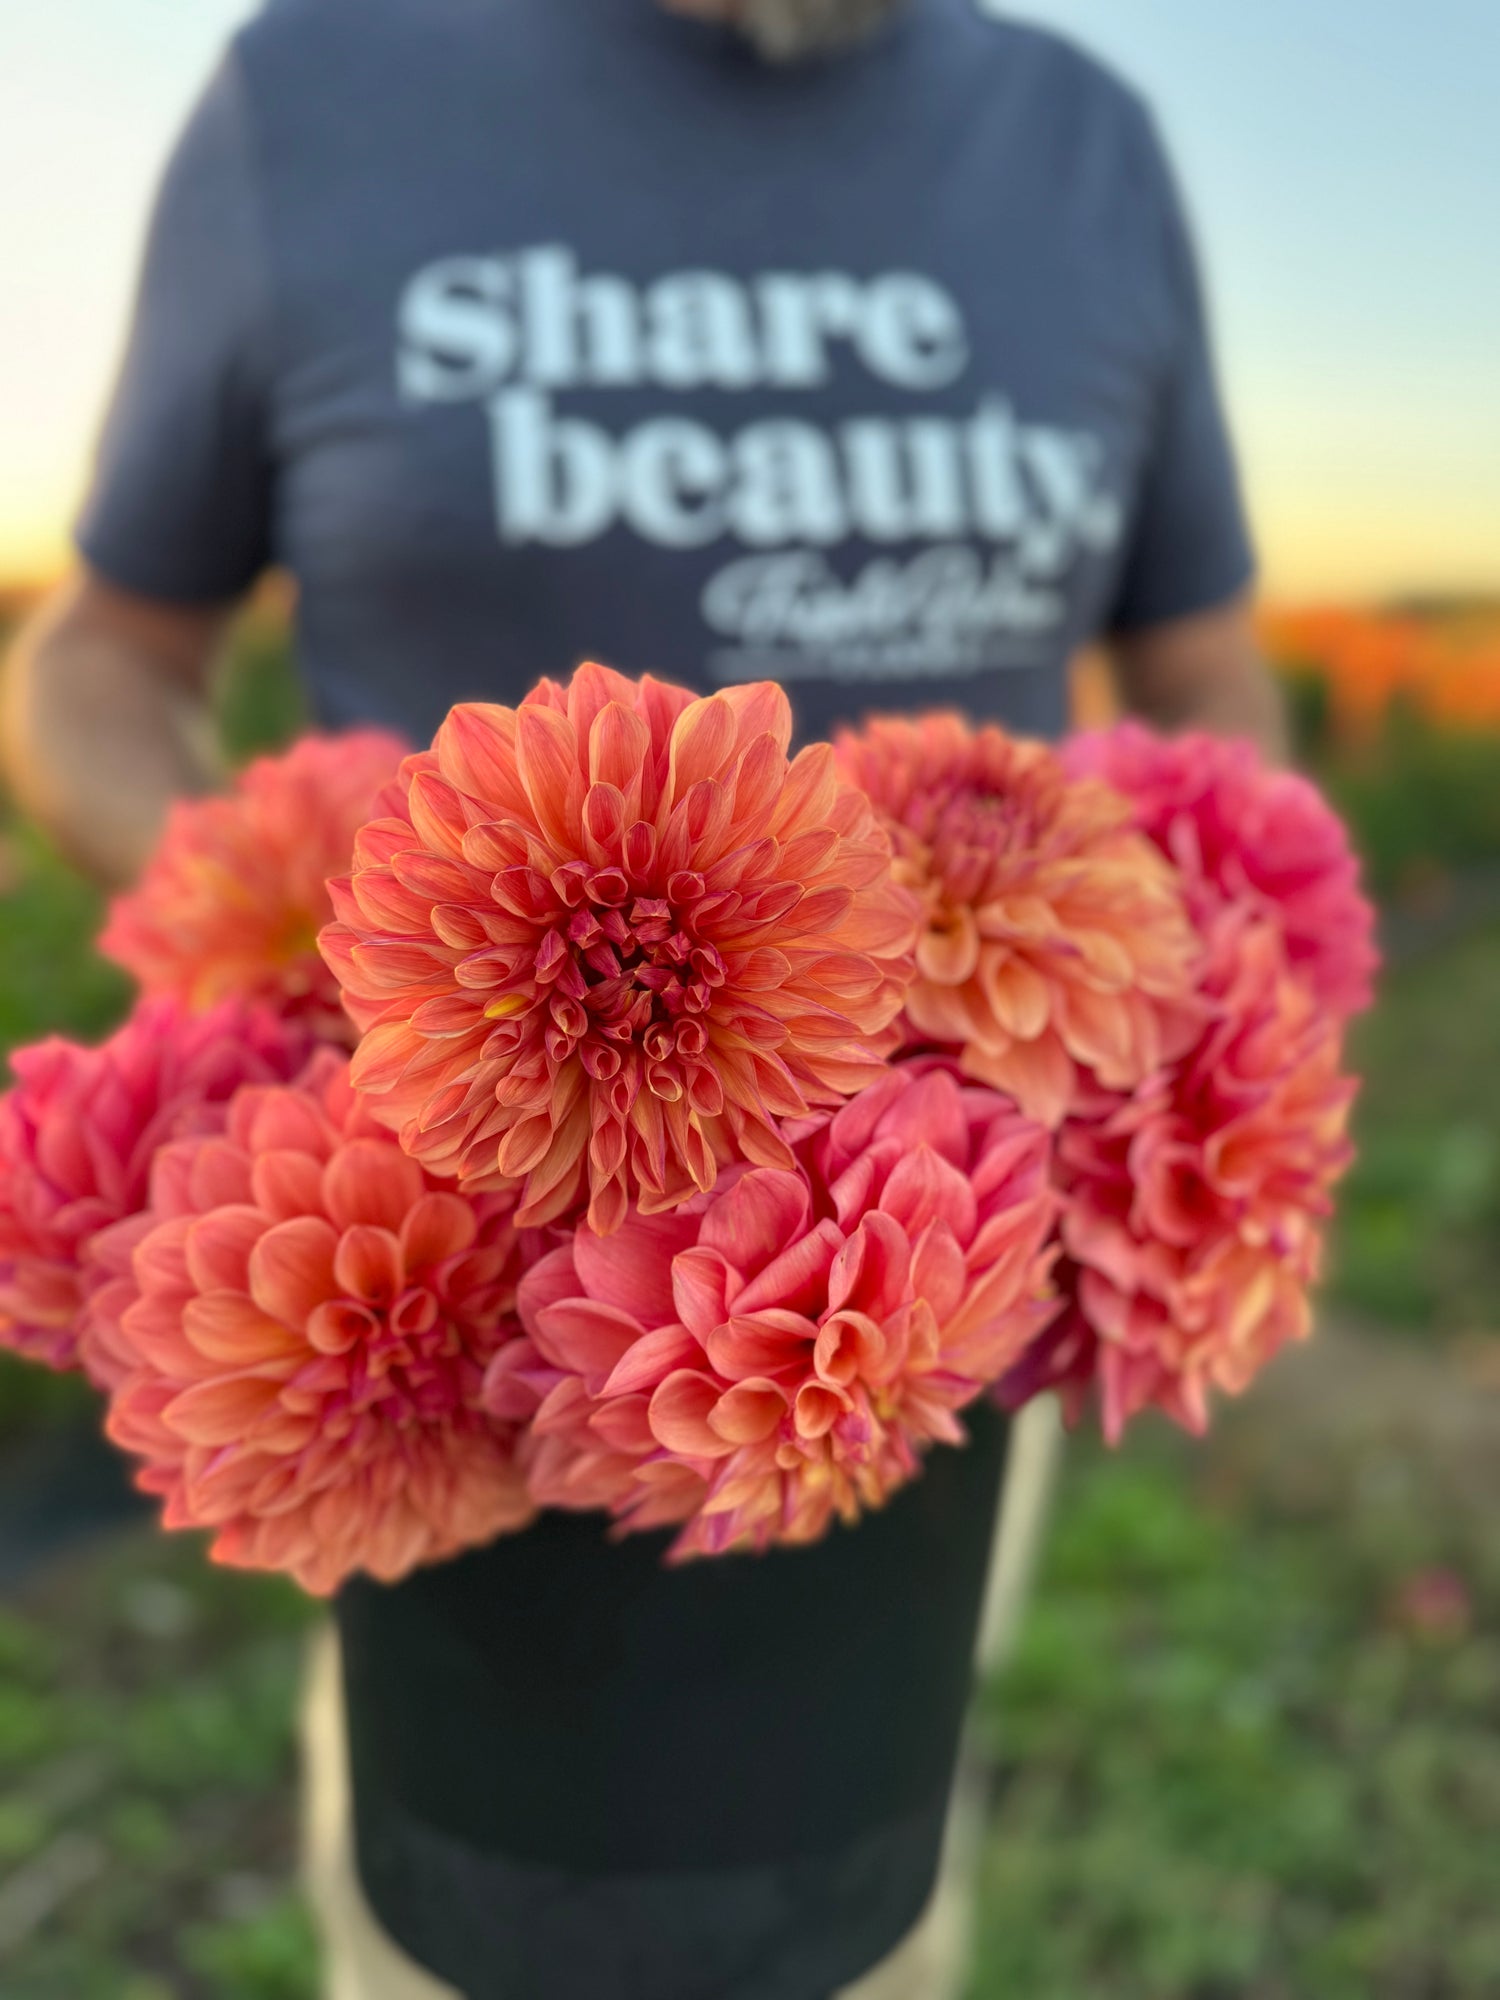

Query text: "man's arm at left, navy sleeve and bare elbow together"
[0, 48, 274, 882]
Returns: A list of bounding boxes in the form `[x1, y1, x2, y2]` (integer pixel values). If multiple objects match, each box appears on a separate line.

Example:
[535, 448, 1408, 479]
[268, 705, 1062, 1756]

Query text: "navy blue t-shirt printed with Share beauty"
[80, 0, 1252, 740]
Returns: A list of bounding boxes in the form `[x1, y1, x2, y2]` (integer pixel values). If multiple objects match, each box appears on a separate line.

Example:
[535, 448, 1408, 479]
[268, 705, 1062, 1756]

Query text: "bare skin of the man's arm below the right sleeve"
[1110, 598, 1288, 762]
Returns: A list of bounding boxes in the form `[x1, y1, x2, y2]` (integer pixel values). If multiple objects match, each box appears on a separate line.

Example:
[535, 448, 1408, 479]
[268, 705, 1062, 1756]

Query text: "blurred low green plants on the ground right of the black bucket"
[972, 1440, 1500, 2000]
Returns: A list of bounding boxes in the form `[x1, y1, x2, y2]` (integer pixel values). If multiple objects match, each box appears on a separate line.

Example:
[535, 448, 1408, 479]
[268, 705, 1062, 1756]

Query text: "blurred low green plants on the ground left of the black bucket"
[0, 1534, 318, 2000]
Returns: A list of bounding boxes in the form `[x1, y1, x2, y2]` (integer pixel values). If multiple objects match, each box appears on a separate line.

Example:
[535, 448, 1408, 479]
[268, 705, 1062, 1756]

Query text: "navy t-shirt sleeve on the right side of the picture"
[1108, 113, 1256, 632]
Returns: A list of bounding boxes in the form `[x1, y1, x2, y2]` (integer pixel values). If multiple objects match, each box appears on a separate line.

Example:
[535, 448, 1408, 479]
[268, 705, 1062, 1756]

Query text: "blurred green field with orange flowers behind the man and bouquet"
[0, 602, 1500, 2000]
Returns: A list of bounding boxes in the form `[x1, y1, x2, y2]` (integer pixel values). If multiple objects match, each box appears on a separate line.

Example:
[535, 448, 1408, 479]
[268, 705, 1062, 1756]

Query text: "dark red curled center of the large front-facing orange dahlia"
[500, 864, 726, 1112]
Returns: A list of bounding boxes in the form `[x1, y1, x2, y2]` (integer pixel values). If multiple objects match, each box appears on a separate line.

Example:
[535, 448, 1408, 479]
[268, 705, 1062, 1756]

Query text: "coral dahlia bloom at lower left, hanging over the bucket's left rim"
[108, 1050, 532, 1594]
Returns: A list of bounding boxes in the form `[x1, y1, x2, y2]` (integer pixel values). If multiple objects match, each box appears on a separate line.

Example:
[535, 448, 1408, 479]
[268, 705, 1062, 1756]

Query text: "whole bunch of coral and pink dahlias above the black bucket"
[0, 666, 1374, 1592]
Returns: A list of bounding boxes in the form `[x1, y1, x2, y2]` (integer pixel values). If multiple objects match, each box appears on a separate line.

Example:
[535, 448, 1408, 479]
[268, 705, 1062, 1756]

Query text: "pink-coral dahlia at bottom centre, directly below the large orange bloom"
[486, 1064, 1056, 1556]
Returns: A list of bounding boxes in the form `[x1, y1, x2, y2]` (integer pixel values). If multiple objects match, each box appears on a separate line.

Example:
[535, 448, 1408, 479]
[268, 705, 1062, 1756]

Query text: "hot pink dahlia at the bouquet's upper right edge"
[1062, 722, 1380, 1020]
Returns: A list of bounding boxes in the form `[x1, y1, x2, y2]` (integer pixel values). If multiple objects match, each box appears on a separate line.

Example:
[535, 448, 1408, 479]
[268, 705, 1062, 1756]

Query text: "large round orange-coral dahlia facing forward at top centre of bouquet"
[322, 666, 916, 1234]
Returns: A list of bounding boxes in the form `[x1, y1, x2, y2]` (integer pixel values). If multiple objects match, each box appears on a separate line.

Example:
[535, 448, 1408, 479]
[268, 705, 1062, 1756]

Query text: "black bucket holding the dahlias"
[338, 1406, 1008, 2000]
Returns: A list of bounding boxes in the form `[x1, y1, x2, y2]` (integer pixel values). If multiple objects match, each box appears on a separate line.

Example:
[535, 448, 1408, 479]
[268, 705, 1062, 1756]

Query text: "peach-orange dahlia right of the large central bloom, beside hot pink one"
[838, 714, 1196, 1126]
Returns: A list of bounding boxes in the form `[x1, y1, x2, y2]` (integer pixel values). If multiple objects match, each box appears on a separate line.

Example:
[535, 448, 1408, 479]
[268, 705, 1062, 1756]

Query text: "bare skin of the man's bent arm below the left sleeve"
[0, 568, 228, 886]
